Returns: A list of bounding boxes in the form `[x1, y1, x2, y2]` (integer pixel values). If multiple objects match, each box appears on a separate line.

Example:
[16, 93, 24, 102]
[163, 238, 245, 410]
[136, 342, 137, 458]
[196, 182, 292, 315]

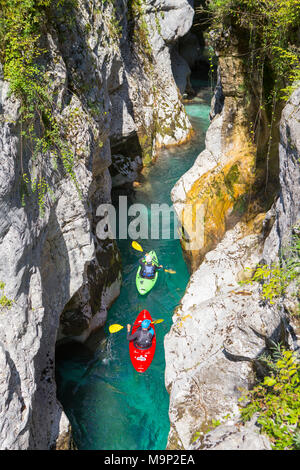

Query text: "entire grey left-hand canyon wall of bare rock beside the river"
[0, 0, 193, 449]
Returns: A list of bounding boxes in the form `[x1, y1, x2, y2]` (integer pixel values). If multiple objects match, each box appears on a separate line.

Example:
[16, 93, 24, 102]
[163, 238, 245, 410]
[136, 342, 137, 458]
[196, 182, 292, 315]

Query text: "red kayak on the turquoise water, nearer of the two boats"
[129, 310, 156, 372]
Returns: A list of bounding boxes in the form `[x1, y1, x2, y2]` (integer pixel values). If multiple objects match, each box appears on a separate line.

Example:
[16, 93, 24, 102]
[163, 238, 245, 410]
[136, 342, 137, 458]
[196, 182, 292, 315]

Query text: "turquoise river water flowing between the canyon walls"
[56, 88, 210, 450]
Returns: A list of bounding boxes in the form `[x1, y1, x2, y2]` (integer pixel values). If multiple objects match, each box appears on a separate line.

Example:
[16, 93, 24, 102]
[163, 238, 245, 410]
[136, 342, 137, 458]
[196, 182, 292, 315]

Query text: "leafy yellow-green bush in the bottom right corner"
[241, 348, 300, 450]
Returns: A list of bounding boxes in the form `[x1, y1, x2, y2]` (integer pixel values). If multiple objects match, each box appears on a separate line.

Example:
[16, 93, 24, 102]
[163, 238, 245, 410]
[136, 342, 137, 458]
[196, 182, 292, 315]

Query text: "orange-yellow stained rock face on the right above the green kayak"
[171, 28, 276, 270]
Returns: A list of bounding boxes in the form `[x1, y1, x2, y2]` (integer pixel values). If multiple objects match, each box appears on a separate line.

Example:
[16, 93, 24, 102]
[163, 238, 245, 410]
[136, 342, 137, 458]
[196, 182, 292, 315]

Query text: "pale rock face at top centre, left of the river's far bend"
[109, 0, 194, 172]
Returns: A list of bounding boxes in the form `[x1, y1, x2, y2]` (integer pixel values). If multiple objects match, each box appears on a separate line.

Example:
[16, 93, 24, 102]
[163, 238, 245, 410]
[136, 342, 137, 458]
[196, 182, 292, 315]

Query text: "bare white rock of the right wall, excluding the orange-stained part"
[165, 80, 300, 450]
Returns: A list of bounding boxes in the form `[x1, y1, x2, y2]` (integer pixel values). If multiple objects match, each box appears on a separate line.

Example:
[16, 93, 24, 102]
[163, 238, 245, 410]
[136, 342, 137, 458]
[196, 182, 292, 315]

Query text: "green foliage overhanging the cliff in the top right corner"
[204, 0, 300, 99]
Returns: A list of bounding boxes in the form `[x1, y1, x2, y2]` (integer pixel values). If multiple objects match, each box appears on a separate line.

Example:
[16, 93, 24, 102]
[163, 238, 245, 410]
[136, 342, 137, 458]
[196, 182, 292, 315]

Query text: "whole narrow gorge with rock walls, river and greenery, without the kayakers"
[0, 0, 300, 451]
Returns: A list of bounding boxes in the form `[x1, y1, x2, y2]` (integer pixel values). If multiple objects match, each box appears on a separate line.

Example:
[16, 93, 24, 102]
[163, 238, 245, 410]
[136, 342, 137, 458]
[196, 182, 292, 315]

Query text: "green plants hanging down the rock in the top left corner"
[0, 0, 77, 214]
